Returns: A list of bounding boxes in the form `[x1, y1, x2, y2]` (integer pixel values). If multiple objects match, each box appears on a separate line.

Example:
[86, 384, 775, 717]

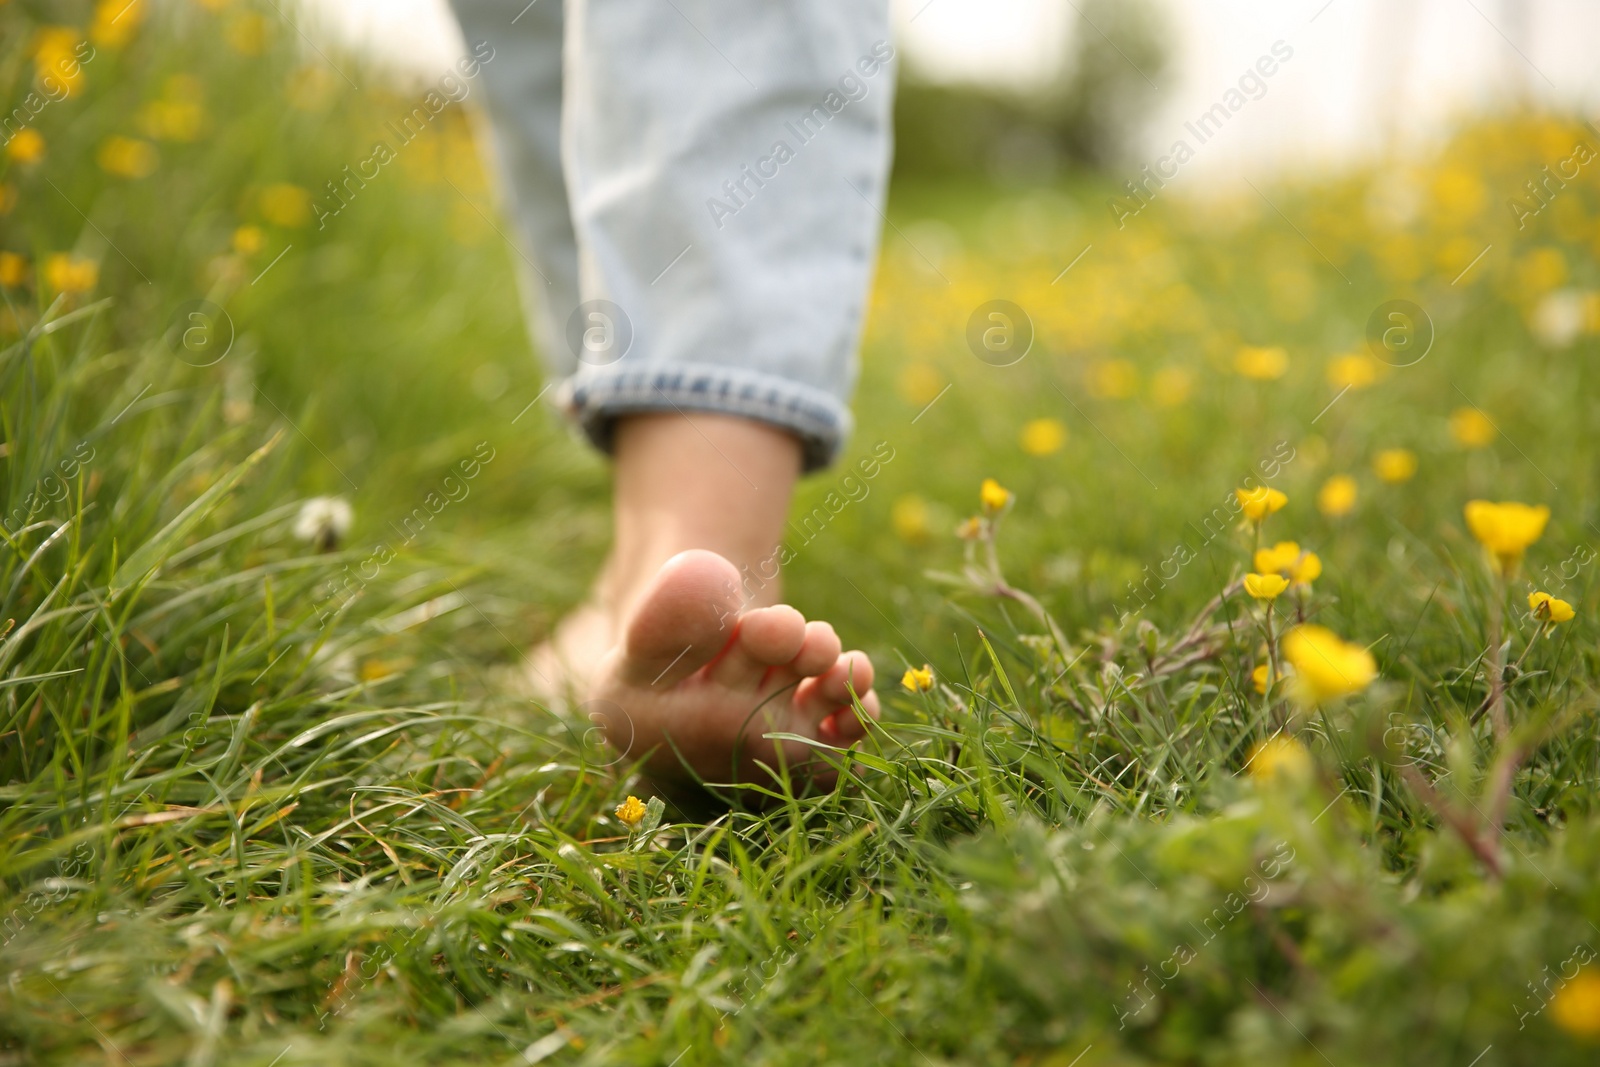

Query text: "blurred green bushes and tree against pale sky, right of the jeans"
[894, 0, 1168, 182]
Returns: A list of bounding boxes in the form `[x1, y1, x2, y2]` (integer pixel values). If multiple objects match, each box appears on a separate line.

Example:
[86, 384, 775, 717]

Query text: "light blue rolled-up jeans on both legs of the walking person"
[453, 0, 894, 470]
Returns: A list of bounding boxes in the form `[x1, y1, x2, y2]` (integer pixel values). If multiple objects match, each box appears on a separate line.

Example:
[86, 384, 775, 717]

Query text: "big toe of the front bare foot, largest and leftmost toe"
[619, 549, 739, 686]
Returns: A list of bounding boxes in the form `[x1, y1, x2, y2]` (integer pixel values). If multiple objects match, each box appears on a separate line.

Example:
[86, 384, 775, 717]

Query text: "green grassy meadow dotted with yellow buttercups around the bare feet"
[0, 0, 1600, 1067]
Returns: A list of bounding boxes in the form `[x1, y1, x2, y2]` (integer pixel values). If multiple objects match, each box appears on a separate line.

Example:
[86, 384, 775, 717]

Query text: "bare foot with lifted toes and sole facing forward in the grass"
[584, 549, 878, 787]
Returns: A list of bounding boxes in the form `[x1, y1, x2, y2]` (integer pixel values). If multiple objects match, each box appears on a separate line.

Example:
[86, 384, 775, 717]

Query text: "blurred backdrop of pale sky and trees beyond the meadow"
[312, 0, 1600, 182]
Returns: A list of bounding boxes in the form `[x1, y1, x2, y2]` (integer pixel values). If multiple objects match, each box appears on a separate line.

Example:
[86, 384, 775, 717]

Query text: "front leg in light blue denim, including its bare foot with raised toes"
[563, 0, 893, 793]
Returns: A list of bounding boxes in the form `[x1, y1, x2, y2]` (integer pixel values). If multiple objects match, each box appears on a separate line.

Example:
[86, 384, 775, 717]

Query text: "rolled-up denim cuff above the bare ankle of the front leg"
[562, 363, 851, 472]
